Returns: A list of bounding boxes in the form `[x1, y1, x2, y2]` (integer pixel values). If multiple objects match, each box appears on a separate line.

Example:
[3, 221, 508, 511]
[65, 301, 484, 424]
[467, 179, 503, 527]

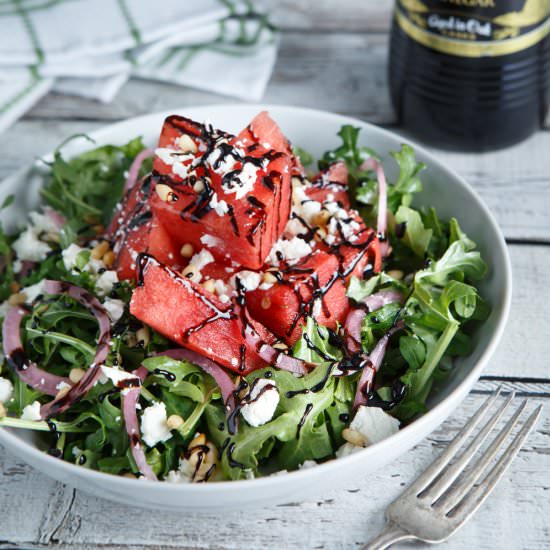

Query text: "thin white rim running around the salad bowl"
[0, 103, 512, 495]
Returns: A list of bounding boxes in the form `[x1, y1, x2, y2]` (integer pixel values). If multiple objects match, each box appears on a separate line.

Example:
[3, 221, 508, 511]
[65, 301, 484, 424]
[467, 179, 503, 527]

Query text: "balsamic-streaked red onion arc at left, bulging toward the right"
[40, 280, 111, 419]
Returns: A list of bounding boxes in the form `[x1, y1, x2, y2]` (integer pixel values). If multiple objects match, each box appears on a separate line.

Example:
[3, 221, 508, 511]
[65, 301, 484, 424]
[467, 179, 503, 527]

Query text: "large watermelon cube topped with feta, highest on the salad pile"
[150, 116, 291, 269]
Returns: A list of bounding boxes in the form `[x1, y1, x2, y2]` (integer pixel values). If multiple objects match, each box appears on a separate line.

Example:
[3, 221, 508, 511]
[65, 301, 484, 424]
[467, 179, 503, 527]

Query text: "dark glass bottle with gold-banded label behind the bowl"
[389, 0, 550, 151]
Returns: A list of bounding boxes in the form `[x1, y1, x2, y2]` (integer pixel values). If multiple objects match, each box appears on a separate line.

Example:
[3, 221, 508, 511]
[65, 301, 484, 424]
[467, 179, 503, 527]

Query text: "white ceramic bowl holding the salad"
[0, 105, 511, 511]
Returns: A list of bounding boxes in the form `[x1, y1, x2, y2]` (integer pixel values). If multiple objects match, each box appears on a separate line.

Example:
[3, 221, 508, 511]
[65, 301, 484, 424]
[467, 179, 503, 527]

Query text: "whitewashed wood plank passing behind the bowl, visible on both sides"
[0, 118, 550, 243]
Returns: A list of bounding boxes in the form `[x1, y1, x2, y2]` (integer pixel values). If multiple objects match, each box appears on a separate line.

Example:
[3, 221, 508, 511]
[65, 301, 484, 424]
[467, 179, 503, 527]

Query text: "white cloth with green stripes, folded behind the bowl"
[0, 0, 277, 132]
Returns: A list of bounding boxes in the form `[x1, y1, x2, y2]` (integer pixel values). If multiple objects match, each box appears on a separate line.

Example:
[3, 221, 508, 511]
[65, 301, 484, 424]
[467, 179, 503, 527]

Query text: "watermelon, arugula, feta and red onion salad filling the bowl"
[0, 112, 489, 483]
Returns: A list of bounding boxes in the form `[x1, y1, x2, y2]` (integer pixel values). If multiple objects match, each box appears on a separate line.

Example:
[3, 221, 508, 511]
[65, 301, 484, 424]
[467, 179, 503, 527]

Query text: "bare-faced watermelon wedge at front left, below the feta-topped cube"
[130, 255, 273, 374]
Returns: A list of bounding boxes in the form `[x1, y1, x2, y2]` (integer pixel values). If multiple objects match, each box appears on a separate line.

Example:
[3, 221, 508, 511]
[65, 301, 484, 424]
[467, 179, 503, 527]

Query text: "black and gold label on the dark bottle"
[395, 0, 550, 57]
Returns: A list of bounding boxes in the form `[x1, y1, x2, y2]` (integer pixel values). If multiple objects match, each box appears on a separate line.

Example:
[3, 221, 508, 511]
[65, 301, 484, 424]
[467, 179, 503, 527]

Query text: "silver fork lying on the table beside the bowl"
[364, 389, 542, 550]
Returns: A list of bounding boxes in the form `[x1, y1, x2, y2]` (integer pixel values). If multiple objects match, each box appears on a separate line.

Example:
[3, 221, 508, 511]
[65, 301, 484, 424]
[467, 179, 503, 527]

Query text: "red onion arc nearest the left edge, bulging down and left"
[2, 307, 72, 395]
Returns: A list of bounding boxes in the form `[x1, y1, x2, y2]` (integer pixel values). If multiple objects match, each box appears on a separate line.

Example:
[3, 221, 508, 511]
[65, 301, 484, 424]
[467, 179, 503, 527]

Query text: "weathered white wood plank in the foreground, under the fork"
[0, 384, 550, 550]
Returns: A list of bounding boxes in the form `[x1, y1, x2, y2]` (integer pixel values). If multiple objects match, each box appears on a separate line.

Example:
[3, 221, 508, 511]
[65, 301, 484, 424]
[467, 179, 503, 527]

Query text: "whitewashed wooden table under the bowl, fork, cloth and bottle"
[0, 0, 550, 550]
